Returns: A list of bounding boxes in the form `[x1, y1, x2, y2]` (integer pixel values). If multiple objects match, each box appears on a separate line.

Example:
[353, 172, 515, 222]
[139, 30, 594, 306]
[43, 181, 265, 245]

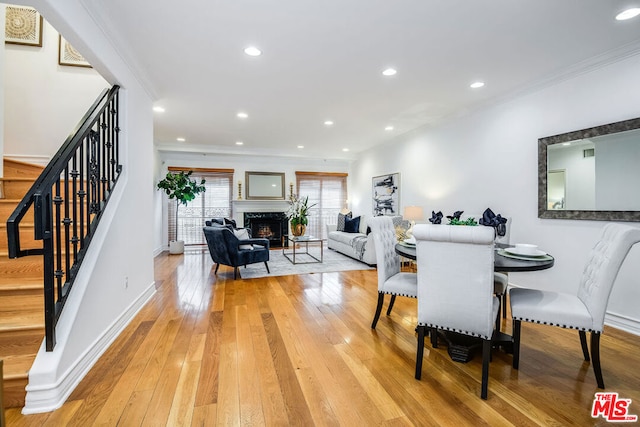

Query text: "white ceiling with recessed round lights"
[83, 0, 640, 159]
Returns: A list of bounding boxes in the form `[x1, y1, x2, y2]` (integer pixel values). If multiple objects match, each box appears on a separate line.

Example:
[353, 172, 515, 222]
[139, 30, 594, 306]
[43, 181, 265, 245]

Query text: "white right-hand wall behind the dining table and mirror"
[350, 52, 640, 334]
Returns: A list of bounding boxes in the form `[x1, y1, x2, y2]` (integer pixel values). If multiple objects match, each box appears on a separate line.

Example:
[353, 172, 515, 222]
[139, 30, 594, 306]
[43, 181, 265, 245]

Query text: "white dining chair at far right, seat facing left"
[509, 224, 640, 388]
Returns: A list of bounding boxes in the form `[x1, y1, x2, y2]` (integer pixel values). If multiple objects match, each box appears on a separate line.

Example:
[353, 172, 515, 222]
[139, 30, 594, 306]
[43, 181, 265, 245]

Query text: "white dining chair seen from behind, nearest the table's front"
[413, 224, 499, 399]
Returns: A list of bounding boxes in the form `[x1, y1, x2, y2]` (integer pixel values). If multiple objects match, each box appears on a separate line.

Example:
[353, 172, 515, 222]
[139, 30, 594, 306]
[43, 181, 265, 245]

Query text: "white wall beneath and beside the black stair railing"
[12, 0, 155, 413]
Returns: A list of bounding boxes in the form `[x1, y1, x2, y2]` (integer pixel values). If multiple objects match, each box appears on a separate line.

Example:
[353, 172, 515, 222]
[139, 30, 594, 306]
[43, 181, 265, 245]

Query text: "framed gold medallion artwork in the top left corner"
[4, 5, 44, 47]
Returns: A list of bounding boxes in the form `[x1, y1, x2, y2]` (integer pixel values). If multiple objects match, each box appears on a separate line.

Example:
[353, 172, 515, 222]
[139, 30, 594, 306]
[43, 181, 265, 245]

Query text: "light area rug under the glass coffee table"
[238, 248, 374, 279]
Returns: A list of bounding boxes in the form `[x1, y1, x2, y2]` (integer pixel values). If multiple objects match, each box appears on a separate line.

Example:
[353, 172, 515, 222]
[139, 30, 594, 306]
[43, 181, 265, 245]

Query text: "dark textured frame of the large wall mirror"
[538, 118, 640, 221]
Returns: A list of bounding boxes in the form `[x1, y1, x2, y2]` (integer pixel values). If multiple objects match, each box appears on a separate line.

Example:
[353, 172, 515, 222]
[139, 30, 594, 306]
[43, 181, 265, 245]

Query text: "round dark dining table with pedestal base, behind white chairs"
[395, 242, 555, 362]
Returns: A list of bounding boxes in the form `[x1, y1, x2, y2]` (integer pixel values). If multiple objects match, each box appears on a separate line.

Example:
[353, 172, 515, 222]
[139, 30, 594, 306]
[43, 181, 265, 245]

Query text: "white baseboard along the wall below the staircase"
[22, 282, 156, 415]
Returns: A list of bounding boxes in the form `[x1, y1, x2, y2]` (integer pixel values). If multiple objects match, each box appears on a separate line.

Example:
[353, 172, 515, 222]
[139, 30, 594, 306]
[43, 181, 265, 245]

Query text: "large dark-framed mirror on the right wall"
[538, 118, 640, 221]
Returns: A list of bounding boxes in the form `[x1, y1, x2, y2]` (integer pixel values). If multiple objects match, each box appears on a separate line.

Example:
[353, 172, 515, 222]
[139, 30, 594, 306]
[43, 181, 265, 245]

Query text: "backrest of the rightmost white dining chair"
[578, 224, 640, 332]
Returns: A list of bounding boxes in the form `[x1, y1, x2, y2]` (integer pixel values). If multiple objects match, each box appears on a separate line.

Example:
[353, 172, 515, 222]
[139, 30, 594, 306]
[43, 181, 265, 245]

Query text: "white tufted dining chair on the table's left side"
[369, 216, 418, 329]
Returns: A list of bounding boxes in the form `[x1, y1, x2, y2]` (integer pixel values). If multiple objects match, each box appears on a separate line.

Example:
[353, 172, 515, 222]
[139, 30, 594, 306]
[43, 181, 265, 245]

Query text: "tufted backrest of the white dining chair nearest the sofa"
[369, 216, 400, 292]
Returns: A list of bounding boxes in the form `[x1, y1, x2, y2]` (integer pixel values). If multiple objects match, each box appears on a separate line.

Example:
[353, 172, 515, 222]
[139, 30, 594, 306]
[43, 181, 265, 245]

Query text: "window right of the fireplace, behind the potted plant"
[296, 172, 347, 239]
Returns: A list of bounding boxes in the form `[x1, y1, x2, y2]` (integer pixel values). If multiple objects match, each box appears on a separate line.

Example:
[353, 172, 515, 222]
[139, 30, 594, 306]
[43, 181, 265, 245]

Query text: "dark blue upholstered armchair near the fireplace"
[203, 225, 269, 279]
